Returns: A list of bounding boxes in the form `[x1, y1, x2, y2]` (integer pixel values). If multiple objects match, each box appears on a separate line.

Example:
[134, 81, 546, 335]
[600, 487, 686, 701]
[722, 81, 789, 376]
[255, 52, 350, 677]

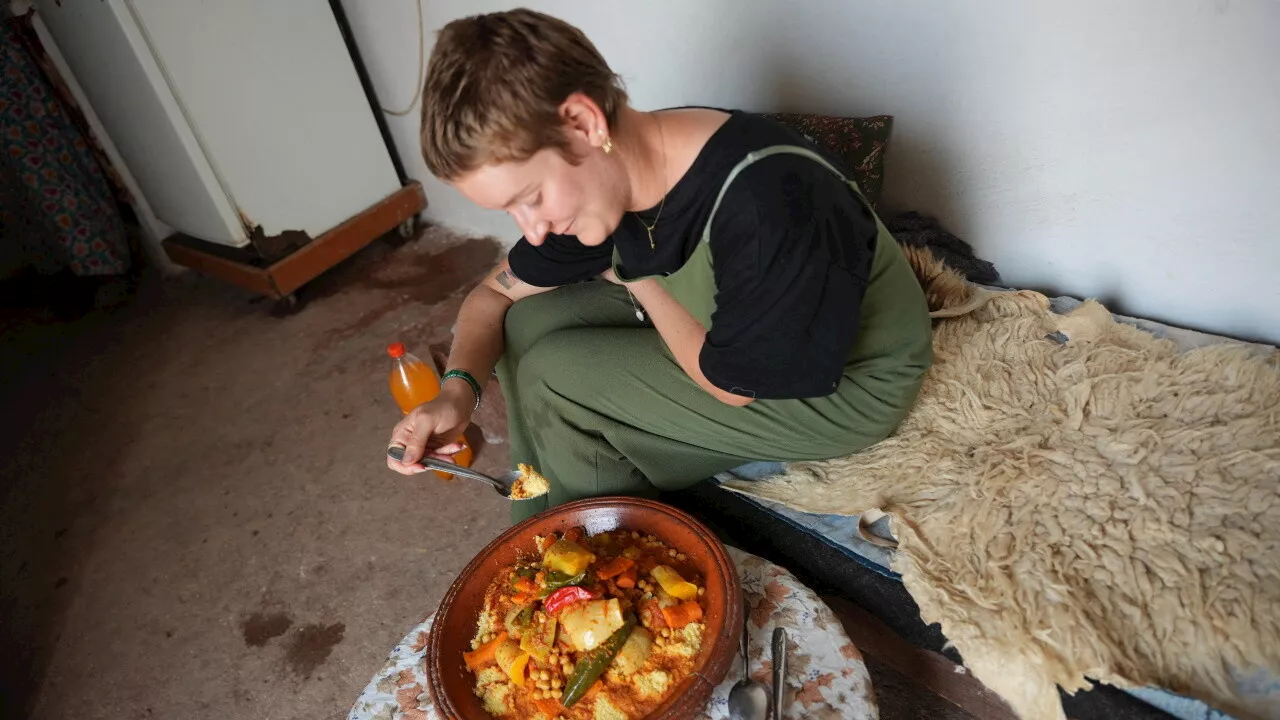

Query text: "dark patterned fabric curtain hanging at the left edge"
[0, 17, 129, 275]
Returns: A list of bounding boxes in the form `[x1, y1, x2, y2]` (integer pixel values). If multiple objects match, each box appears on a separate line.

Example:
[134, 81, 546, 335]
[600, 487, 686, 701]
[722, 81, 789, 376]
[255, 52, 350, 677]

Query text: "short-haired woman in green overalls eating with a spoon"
[388, 10, 931, 520]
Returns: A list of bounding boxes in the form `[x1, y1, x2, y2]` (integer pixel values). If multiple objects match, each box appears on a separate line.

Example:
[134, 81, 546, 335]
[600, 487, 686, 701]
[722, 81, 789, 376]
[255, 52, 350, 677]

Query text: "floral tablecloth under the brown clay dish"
[347, 547, 879, 720]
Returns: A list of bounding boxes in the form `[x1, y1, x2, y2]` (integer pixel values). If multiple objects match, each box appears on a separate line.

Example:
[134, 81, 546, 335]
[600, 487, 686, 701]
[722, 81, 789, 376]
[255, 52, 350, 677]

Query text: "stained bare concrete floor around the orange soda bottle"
[0, 231, 966, 720]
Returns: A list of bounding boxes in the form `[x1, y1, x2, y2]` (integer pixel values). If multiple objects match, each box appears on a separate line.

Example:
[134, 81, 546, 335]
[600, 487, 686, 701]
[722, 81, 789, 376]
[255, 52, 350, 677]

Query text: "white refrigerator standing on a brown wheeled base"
[35, 0, 425, 296]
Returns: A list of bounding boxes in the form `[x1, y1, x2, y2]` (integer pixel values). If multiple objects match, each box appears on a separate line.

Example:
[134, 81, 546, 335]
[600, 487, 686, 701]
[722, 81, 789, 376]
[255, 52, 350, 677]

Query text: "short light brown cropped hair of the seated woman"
[422, 9, 627, 181]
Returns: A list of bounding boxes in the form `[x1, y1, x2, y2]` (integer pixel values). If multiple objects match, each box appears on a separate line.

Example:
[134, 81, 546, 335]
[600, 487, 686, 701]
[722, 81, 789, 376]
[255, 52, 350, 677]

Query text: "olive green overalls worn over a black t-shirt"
[498, 145, 932, 521]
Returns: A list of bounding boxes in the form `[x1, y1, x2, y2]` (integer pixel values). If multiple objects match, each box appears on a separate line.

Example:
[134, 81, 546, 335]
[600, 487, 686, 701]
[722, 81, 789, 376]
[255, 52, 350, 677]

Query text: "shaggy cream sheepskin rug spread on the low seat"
[726, 275, 1280, 720]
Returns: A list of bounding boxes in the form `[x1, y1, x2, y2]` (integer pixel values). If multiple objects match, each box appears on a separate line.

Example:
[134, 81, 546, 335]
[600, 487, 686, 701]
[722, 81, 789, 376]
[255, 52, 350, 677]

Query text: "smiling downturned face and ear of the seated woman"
[453, 94, 628, 245]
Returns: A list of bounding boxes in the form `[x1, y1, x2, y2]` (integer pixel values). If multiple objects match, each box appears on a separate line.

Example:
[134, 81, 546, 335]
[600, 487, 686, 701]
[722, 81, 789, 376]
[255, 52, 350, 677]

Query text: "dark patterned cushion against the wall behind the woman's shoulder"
[764, 113, 893, 205]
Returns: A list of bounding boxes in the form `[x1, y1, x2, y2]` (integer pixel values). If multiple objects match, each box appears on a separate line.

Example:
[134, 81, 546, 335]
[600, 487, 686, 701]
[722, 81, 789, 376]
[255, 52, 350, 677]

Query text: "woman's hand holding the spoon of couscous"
[387, 382, 476, 475]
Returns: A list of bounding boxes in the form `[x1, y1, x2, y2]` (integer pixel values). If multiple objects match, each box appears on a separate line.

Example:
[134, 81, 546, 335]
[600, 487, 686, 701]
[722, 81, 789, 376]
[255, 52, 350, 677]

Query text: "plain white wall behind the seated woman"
[344, 0, 1280, 342]
